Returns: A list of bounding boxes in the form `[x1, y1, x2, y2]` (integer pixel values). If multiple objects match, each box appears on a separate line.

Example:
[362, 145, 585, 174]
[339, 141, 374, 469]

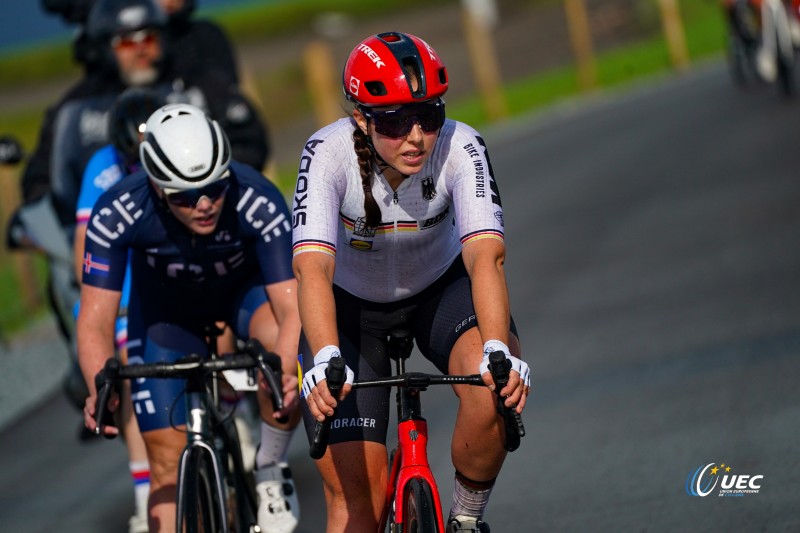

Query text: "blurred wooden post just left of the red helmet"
[303, 39, 343, 127]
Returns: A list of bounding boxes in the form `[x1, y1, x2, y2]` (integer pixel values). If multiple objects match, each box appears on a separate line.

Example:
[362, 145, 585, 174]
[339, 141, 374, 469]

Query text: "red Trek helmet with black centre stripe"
[342, 32, 447, 107]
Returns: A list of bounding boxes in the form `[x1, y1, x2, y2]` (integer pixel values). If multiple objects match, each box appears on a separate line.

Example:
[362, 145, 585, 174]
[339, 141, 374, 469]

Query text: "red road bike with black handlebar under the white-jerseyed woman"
[310, 330, 525, 533]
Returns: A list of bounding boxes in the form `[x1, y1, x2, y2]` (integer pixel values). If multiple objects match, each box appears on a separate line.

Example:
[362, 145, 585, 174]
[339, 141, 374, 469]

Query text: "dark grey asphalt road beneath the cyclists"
[0, 60, 800, 533]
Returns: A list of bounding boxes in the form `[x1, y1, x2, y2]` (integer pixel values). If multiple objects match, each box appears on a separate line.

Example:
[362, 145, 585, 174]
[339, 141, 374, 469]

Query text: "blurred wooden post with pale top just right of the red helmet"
[463, 3, 508, 122]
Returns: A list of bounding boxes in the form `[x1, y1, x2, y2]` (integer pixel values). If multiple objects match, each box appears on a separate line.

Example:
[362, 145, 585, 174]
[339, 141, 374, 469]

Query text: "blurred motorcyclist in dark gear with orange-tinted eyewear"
[18, 0, 269, 422]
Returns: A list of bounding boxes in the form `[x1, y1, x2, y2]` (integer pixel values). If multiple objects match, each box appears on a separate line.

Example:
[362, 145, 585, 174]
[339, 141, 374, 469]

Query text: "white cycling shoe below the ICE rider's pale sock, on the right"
[255, 463, 300, 533]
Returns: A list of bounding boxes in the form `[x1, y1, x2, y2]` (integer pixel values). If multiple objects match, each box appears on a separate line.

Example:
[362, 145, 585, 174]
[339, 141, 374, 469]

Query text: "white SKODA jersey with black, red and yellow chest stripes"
[292, 118, 503, 302]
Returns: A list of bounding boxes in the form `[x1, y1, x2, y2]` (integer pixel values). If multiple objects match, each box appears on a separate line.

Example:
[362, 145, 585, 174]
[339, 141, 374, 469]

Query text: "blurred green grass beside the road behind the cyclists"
[0, 0, 725, 333]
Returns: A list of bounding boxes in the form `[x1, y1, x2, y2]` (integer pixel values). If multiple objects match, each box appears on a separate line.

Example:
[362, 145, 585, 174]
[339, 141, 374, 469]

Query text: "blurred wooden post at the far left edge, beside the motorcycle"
[0, 166, 42, 310]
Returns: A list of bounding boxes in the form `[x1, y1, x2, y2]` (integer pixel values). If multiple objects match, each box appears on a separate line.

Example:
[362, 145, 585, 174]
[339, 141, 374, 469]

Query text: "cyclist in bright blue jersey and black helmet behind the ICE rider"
[74, 88, 166, 533]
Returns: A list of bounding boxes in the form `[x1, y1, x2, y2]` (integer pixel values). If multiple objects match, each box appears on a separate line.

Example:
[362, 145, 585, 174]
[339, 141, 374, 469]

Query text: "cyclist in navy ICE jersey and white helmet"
[77, 104, 300, 532]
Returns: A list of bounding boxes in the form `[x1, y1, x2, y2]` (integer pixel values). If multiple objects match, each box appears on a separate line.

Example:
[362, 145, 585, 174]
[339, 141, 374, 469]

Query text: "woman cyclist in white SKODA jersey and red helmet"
[292, 32, 530, 532]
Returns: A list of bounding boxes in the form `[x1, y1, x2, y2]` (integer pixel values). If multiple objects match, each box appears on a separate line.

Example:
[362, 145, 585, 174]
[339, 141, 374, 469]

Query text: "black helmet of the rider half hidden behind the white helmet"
[108, 87, 167, 166]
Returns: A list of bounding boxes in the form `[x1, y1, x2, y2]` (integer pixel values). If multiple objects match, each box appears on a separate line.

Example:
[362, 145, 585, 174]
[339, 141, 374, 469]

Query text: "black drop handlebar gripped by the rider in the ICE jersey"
[95, 339, 286, 439]
